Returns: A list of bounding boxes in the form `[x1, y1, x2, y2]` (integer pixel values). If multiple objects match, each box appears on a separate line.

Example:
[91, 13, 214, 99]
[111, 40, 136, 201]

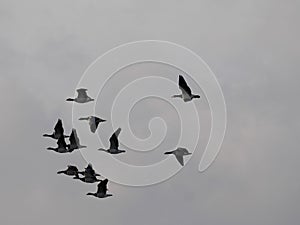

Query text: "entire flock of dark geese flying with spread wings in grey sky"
[43, 75, 200, 198]
